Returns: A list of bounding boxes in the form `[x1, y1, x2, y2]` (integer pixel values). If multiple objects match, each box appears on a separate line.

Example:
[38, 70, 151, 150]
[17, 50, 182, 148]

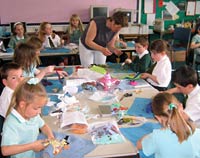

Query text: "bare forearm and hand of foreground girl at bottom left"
[1, 140, 47, 156]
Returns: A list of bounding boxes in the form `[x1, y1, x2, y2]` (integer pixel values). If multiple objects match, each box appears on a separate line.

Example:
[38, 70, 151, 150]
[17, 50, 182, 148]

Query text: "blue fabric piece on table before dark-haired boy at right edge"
[127, 98, 154, 118]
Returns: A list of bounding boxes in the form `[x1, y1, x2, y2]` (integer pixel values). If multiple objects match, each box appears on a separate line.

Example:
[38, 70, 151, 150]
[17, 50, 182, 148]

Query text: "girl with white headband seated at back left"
[8, 22, 28, 49]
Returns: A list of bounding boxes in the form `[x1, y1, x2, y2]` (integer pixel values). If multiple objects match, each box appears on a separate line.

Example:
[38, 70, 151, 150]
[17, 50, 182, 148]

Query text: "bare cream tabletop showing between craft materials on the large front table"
[43, 65, 158, 158]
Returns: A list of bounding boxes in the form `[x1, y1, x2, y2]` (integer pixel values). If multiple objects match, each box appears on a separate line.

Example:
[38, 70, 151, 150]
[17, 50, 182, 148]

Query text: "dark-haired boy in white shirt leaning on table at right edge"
[167, 66, 200, 127]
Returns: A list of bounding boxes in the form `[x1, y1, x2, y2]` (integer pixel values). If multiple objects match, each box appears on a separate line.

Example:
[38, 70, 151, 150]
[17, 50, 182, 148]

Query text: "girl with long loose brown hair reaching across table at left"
[13, 43, 54, 80]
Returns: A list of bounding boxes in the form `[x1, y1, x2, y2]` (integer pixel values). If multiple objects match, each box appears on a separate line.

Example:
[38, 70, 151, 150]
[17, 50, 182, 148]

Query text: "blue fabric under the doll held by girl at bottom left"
[36, 133, 96, 158]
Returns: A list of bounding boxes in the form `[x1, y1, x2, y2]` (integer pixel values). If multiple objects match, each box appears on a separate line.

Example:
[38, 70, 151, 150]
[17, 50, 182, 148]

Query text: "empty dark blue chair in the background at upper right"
[170, 27, 191, 68]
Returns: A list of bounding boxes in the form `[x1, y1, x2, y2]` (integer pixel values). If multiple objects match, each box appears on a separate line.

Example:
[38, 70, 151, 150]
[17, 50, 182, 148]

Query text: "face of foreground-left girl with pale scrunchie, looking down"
[19, 96, 47, 119]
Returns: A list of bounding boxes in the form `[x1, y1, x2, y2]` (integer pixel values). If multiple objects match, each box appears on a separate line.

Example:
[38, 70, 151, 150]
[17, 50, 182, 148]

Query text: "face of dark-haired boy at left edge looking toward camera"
[3, 69, 24, 90]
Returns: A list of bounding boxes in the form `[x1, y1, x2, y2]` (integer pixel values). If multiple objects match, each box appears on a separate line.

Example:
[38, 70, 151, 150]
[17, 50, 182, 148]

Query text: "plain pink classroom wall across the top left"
[0, 0, 138, 24]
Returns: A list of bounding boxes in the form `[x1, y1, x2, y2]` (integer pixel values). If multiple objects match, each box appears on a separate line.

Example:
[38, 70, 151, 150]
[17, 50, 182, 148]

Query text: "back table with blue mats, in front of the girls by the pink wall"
[0, 48, 78, 61]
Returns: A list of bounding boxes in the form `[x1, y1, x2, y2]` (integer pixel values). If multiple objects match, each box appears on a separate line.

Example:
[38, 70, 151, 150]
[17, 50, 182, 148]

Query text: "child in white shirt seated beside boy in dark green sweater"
[141, 39, 172, 91]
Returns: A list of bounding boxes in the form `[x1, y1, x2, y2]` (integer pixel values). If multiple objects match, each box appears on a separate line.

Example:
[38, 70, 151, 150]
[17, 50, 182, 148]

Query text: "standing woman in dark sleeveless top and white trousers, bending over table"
[79, 12, 128, 67]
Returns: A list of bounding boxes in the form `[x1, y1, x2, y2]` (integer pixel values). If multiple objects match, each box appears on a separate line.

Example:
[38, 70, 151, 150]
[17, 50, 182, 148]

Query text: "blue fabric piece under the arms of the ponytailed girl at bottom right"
[120, 122, 161, 158]
